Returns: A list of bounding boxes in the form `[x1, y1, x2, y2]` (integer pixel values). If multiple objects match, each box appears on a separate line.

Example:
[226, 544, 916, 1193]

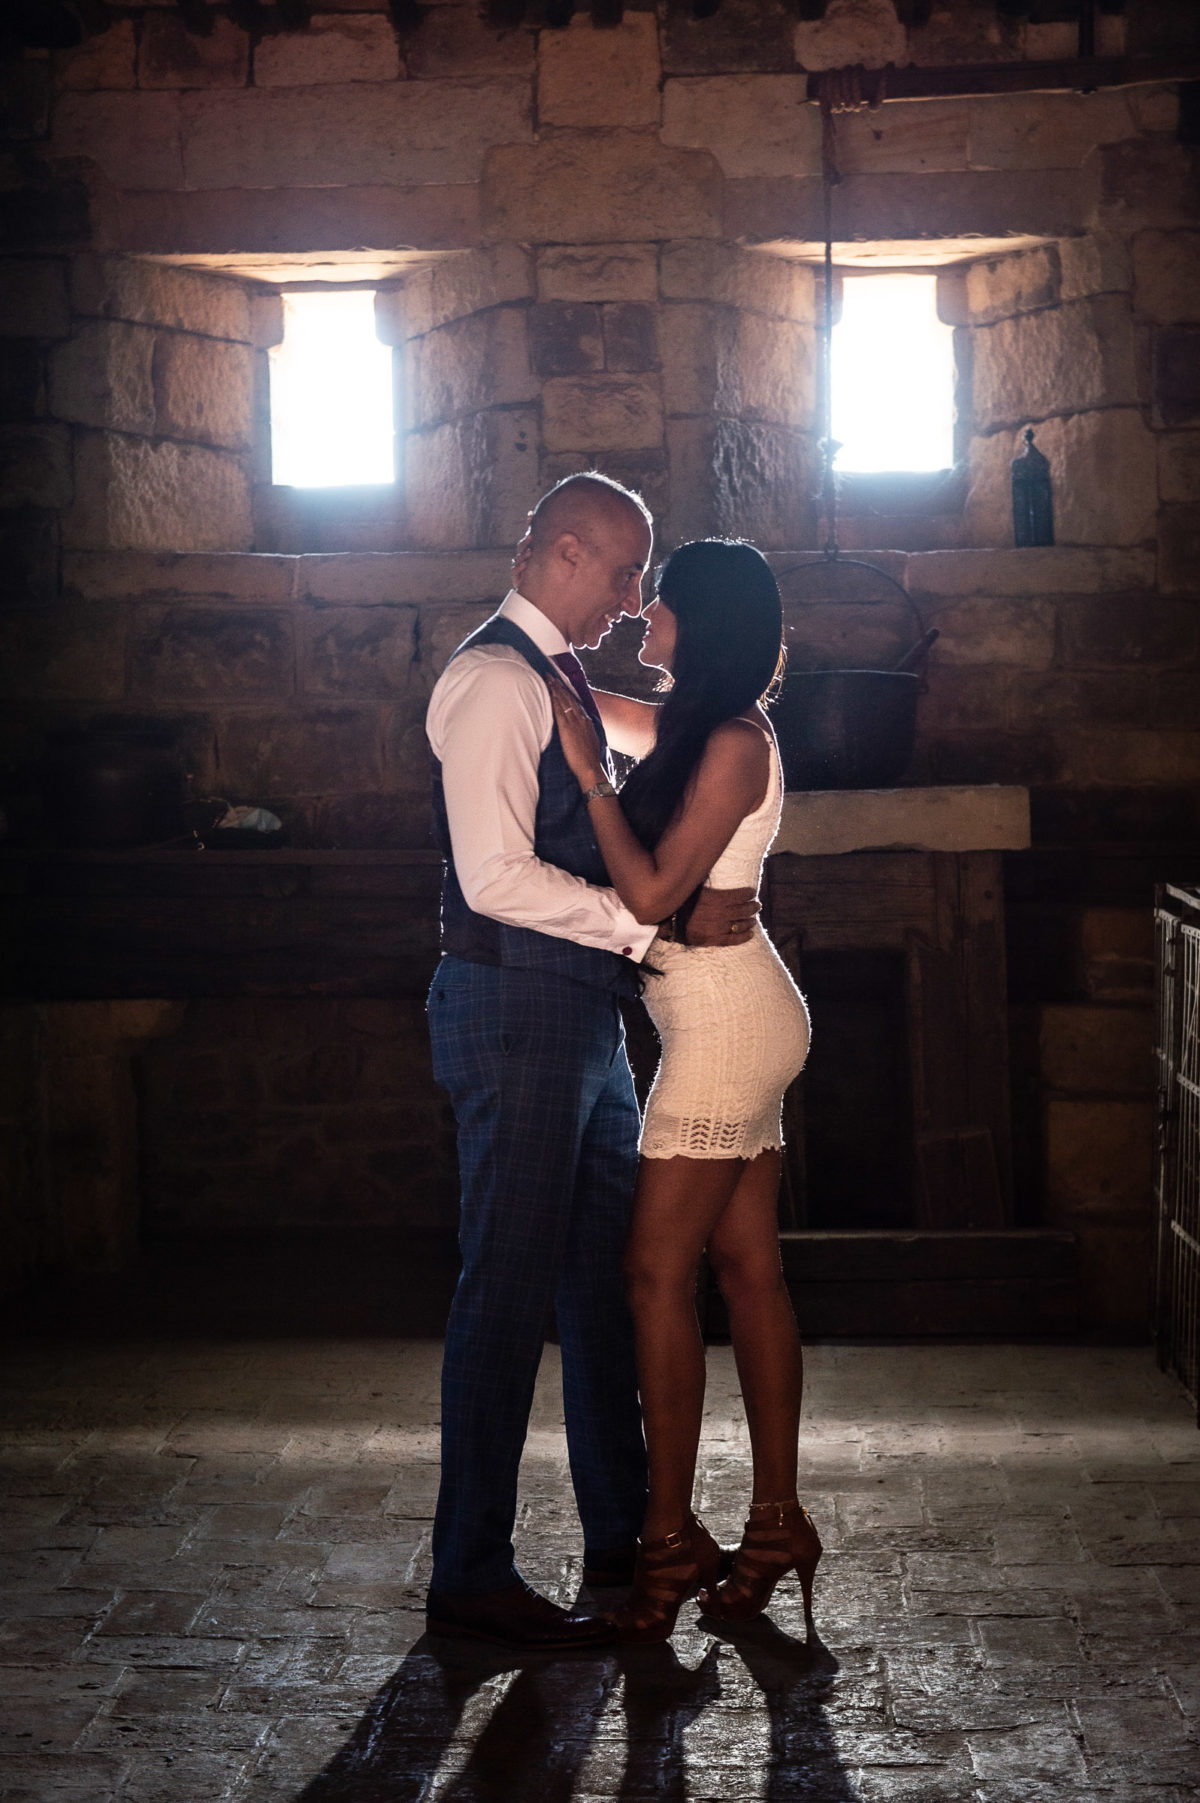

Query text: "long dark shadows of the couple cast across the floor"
[295, 1621, 859, 1803]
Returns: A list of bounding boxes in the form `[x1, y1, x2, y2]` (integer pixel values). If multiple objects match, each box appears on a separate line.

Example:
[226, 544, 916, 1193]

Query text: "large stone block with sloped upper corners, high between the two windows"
[483, 130, 723, 243]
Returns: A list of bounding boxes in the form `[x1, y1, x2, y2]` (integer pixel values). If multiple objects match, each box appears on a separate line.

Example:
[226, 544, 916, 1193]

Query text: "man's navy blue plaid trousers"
[429, 957, 645, 1596]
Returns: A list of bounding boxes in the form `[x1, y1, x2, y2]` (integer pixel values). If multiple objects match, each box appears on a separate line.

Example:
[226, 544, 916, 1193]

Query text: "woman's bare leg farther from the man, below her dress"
[708, 1152, 804, 1502]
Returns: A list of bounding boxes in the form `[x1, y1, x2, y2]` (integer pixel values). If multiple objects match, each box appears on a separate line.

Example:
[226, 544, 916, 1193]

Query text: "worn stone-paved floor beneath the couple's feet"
[0, 1340, 1200, 1803]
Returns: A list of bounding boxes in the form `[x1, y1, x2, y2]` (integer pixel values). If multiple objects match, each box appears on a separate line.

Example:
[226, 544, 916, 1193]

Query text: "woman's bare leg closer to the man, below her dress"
[625, 1158, 746, 1540]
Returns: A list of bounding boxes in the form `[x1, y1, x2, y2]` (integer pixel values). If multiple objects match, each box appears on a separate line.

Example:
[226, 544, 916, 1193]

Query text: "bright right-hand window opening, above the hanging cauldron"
[832, 276, 955, 471]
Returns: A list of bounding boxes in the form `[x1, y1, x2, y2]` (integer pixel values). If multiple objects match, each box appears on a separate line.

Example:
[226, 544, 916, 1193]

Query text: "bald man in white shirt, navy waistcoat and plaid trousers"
[427, 474, 755, 1648]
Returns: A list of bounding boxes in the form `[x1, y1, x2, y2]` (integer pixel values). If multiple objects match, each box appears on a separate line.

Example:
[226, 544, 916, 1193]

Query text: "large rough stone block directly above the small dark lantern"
[975, 294, 1141, 431]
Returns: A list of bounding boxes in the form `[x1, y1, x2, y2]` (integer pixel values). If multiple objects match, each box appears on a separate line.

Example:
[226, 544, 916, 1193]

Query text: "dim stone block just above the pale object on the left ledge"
[216, 705, 382, 799]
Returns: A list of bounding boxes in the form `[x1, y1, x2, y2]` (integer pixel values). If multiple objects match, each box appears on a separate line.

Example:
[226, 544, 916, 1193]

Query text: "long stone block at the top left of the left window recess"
[70, 254, 250, 343]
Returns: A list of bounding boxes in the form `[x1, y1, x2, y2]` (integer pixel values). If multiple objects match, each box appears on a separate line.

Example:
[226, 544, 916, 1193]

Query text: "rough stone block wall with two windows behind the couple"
[0, 0, 1200, 1329]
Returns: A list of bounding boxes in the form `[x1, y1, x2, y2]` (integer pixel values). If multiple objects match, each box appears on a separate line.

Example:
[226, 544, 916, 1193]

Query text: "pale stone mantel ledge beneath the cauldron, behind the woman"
[771, 783, 1031, 858]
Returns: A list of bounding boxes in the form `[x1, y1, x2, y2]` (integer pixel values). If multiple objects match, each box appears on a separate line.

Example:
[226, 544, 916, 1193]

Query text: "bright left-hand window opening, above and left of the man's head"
[270, 288, 396, 489]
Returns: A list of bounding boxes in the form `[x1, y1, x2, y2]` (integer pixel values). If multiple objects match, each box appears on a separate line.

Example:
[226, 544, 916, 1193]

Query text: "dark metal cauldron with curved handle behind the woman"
[771, 557, 937, 790]
